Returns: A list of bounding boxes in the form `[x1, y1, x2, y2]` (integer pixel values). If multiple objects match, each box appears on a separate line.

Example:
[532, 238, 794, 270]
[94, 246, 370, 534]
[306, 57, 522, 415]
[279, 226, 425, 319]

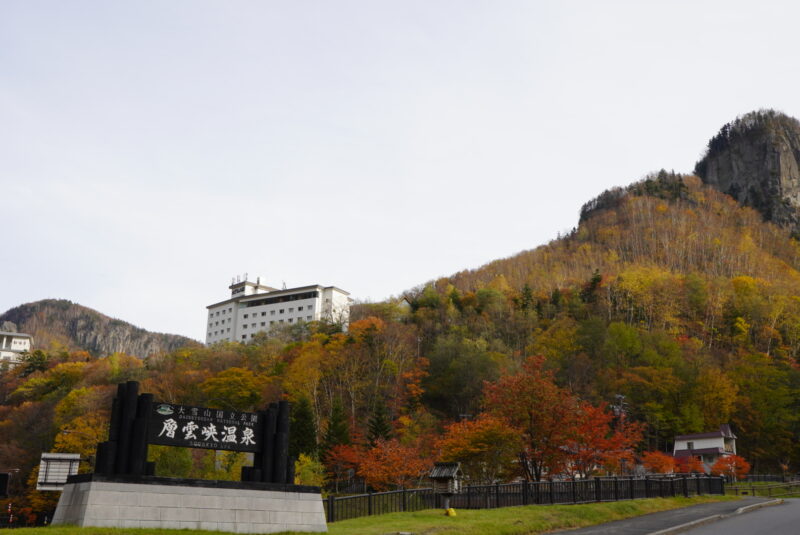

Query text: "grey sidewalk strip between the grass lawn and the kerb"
[561, 497, 776, 535]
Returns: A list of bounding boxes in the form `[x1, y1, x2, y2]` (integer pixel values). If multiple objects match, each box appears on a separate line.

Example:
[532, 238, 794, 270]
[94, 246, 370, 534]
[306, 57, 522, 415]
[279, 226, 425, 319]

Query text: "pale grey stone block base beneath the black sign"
[52, 474, 328, 533]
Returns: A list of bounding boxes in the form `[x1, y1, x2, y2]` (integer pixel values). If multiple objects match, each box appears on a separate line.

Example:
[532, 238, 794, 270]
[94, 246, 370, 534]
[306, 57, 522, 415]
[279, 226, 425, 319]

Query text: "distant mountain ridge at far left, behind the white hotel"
[0, 299, 198, 358]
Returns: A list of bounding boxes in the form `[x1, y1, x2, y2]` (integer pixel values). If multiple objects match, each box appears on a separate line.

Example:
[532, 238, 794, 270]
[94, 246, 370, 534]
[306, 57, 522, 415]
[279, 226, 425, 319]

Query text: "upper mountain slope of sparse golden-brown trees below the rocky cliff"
[437, 172, 800, 298]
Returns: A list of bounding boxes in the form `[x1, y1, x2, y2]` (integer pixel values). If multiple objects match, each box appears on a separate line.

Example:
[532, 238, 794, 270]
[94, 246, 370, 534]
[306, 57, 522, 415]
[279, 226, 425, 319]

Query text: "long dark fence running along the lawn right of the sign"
[325, 476, 725, 522]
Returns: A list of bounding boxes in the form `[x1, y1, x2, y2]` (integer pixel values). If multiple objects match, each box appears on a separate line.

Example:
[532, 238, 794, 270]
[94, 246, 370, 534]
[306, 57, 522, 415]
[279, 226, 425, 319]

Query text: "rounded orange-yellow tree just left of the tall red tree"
[436, 414, 522, 483]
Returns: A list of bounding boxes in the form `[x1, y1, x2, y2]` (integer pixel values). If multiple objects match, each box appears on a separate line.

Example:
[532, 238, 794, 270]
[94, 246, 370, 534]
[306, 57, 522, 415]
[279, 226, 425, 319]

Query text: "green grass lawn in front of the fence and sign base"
[14, 496, 736, 535]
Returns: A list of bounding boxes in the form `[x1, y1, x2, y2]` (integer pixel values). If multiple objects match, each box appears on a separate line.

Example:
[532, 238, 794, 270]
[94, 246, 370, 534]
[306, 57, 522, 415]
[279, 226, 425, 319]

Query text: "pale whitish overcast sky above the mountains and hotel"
[0, 0, 800, 339]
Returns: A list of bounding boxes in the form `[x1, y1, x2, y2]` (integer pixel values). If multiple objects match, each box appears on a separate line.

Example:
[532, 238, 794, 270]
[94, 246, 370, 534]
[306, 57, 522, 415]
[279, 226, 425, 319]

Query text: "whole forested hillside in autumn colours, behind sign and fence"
[0, 113, 800, 520]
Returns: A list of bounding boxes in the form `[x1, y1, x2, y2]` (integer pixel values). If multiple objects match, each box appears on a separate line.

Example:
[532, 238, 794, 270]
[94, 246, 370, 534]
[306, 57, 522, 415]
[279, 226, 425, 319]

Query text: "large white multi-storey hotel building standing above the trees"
[206, 277, 351, 344]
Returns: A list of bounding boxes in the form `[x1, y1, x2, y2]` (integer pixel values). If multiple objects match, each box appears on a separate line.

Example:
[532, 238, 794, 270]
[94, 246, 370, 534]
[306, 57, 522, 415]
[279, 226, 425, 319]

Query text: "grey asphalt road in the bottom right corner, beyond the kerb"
[685, 498, 800, 535]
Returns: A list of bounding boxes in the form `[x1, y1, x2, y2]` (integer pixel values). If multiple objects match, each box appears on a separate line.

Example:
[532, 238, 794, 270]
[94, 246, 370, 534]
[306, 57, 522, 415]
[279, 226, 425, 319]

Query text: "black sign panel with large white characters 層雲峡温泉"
[147, 402, 264, 452]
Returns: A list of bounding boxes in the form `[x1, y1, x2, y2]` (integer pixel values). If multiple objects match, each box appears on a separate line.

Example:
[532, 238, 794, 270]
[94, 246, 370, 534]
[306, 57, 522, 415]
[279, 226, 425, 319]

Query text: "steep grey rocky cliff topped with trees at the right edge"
[695, 110, 800, 234]
